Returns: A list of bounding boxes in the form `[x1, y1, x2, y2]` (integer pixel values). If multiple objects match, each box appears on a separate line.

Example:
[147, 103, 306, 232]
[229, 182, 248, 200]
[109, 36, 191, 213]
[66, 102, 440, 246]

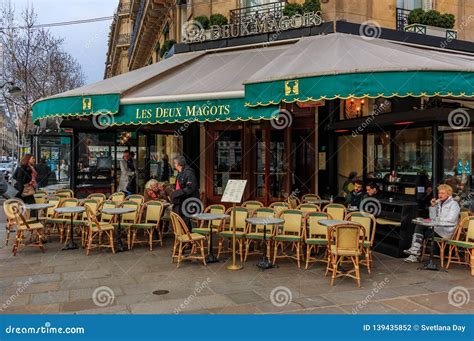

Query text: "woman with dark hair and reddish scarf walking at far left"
[15, 154, 38, 204]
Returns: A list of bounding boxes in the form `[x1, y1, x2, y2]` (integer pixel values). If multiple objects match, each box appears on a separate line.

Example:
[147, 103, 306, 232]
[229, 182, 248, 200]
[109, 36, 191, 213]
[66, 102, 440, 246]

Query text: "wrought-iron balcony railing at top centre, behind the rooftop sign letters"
[230, 1, 286, 24]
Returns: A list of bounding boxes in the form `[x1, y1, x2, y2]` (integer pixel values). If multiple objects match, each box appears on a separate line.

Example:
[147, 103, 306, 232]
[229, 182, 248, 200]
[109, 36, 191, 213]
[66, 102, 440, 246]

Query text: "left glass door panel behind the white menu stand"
[213, 130, 242, 196]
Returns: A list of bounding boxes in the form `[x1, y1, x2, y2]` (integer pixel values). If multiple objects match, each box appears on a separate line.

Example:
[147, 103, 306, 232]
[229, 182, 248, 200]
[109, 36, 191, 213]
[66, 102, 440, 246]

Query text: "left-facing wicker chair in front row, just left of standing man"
[130, 200, 164, 251]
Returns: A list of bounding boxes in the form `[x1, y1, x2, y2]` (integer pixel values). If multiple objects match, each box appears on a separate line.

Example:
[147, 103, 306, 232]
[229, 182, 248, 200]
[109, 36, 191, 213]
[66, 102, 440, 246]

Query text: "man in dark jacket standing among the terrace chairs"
[171, 156, 202, 230]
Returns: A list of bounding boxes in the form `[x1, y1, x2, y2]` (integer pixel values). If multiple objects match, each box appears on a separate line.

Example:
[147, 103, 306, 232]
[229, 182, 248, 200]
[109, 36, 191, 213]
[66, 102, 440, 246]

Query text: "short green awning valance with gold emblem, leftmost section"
[32, 94, 120, 123]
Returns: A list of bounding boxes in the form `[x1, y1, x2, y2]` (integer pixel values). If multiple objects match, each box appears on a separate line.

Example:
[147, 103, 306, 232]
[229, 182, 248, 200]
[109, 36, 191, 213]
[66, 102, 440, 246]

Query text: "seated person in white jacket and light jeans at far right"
[403, 185, 461, 263]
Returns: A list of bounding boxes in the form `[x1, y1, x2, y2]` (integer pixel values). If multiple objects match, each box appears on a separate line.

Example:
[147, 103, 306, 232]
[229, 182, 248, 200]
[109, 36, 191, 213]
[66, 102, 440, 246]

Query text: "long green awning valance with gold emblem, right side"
[245, 71, 474, 107]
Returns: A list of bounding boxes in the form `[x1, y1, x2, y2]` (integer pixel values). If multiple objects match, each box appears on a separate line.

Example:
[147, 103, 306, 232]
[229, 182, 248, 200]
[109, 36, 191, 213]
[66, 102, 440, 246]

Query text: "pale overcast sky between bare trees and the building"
[10, 0, 119, 83]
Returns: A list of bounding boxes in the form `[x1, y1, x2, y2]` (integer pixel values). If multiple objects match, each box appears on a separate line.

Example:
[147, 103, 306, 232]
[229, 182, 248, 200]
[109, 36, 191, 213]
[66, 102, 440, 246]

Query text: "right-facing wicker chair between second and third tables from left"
[84, 204, 115, 256]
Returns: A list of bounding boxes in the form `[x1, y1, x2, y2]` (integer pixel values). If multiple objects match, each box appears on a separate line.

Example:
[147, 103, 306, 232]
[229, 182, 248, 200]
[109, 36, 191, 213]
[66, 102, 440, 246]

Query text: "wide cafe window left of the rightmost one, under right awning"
[394, 127, 433, 178]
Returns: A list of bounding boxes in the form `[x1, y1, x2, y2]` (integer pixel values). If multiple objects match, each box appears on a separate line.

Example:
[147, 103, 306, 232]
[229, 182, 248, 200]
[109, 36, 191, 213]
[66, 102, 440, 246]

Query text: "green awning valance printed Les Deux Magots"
[110, 98, 278, 126]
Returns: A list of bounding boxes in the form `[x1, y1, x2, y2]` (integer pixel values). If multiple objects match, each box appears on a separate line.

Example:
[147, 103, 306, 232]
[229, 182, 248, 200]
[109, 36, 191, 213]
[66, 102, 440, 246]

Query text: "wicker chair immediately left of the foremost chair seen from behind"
[305, 212, 332, 269]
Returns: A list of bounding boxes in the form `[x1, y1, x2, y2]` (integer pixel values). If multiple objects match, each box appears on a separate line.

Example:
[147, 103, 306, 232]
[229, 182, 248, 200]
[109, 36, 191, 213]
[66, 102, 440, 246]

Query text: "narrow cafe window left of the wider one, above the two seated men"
[367, 132, 391, 178]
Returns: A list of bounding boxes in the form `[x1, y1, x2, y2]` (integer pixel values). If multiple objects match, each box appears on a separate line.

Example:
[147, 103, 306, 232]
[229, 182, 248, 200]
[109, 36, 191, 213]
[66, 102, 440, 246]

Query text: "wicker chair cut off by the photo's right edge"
[446, 216, 474, 276]
